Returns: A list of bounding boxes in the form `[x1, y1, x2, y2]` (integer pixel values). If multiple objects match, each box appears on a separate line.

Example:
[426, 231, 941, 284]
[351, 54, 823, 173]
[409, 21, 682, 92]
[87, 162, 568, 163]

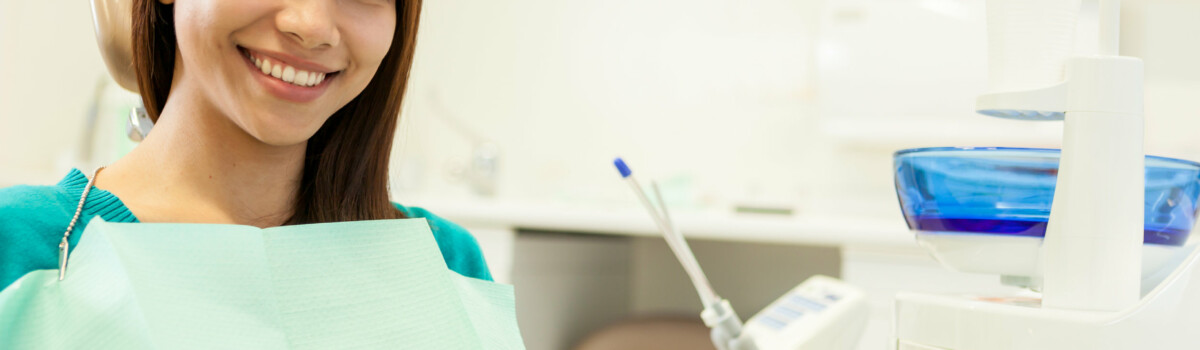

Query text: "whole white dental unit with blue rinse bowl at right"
[892, 0, 1200, 350]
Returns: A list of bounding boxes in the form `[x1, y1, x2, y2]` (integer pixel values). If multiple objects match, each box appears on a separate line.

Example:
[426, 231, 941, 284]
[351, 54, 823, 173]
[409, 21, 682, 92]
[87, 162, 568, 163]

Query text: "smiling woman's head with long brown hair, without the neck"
[131, 0, 410, 224]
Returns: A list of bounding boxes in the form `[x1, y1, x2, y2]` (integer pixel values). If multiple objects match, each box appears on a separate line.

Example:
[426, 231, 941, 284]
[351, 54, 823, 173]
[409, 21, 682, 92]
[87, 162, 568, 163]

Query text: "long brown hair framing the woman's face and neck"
[131, 0, 421, 224]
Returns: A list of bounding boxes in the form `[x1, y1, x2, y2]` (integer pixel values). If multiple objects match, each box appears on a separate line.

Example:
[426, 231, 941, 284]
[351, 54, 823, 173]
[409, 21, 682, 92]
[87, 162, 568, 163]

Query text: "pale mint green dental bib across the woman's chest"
[0, 217, 524, 349]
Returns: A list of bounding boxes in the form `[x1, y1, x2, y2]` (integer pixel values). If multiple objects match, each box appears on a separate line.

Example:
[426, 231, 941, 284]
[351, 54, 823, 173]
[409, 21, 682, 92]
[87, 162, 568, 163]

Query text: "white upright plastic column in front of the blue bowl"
[1043, 56, 1146, 310]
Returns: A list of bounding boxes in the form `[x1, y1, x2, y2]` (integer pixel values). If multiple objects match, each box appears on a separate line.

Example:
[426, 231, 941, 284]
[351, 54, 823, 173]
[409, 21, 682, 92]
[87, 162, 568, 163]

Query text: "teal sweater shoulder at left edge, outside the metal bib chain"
[0, 186, 73, 290]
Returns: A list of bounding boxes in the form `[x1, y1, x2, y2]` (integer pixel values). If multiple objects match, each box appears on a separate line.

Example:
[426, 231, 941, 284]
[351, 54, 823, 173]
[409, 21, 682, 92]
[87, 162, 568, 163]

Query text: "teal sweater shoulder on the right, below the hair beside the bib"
[392, 203, 492, 280]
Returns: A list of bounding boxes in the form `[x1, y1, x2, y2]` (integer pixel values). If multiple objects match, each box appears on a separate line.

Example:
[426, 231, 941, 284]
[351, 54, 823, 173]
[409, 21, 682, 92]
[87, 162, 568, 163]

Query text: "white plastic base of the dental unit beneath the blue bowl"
[893, 240, 1200, 350]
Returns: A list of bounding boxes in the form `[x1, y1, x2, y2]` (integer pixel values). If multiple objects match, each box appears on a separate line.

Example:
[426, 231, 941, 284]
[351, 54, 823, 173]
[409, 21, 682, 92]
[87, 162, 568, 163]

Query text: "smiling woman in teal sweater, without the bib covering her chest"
[0, 0, 491, 293]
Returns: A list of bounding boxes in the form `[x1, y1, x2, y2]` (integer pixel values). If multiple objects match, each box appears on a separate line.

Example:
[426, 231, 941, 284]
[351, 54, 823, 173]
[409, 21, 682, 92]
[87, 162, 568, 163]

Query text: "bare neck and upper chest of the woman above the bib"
[96, 91, 306, 228]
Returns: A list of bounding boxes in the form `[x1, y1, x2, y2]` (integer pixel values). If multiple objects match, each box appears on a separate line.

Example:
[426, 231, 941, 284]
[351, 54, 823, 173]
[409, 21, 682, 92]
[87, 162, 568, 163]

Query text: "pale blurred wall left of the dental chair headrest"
[0, 1, 107, 187]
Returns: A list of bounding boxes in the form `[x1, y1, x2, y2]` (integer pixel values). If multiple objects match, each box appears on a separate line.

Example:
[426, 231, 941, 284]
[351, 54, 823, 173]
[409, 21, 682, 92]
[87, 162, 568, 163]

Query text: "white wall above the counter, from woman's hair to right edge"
[397, 0, 1200, 216]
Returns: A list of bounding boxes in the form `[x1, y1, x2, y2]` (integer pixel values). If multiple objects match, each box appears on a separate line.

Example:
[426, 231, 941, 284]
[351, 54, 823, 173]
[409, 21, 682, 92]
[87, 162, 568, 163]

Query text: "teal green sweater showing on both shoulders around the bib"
[0, 169, 492, 290]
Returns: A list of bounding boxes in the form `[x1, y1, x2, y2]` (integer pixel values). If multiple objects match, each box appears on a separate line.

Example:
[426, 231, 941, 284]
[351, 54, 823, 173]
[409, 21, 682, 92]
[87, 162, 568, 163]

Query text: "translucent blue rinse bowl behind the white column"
[895, 147, 1200, 246]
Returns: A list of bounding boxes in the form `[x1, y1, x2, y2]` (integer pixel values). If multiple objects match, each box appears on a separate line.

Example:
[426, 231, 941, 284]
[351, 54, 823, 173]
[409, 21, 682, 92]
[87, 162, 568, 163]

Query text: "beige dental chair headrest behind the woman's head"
[91, 0, 138, 92]
